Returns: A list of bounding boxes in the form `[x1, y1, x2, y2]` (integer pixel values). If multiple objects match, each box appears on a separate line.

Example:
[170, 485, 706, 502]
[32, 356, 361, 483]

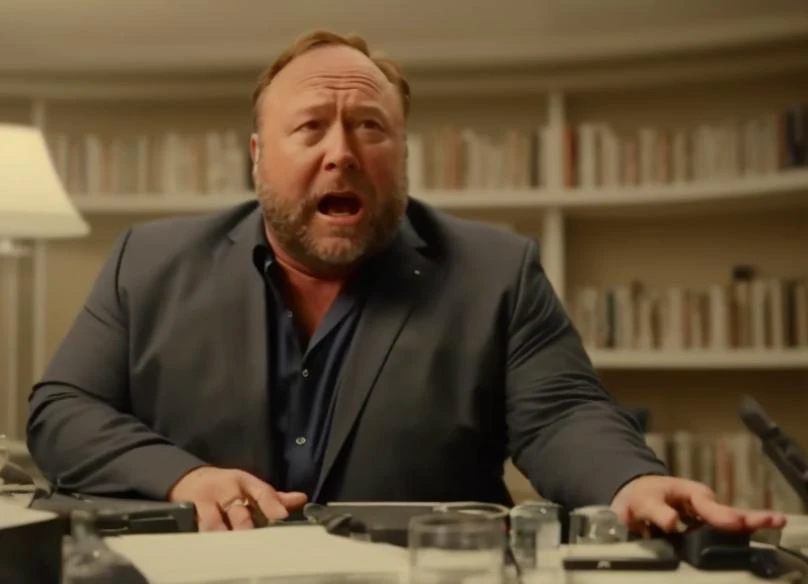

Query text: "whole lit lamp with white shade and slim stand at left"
[0, 124, 90, 438]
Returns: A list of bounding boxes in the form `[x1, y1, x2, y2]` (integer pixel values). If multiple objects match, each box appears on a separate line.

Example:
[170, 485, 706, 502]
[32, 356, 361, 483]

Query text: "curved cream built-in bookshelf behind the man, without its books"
[0, 38, 808, 508]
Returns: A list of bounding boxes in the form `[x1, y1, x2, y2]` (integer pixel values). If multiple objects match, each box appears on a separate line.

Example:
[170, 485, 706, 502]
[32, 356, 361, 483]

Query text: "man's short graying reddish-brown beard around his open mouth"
[256, 175, 407, 273]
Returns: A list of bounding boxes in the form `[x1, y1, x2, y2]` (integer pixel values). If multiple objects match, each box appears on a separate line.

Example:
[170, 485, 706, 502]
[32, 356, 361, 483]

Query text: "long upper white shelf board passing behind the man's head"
[74, 169, 808, 213]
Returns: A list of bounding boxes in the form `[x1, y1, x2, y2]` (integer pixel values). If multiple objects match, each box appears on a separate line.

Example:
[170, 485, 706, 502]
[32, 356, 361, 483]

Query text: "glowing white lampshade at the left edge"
[0, 124, 90, 239]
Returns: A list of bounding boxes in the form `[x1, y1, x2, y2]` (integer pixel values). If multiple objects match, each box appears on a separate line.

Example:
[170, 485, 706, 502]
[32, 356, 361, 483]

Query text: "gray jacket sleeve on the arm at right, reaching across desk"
[506, 242, 668, 508]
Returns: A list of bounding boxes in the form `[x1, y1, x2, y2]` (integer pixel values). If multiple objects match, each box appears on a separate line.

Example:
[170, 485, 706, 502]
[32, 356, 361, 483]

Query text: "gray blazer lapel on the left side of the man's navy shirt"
[214, 209, 276, 484]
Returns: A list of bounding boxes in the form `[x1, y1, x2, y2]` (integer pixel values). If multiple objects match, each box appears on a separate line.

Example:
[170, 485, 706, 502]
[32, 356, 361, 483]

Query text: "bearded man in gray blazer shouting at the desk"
[28, 33, 782, 529]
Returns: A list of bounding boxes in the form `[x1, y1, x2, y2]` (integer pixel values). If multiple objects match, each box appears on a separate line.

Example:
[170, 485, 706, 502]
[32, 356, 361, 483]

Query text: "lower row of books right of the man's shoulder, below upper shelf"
[570, 271, 808, 351]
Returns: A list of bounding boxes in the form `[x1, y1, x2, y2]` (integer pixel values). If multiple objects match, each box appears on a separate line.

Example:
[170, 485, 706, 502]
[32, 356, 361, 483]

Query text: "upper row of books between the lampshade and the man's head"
[46, 130, 251, 195]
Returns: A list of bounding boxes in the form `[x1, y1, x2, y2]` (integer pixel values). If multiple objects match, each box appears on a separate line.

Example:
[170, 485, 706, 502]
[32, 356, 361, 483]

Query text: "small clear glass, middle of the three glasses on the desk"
[510, 501, 561, 570]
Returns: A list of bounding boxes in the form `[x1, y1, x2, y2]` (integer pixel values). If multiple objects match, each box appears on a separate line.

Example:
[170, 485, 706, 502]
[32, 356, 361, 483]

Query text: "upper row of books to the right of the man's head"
[409, 104, 808, 190]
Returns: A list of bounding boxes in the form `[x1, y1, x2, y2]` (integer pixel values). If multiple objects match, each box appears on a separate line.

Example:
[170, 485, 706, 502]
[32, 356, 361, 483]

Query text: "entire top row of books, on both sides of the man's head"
[47, 105, 808, 195]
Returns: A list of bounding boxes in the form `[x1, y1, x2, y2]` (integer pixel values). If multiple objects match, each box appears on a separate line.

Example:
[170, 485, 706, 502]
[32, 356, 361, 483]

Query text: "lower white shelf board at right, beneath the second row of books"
[589, 348, 808, 369]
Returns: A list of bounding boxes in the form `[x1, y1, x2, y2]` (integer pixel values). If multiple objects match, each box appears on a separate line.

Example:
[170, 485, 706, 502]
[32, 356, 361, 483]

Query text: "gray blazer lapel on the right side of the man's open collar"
[314, 220, 438, 500]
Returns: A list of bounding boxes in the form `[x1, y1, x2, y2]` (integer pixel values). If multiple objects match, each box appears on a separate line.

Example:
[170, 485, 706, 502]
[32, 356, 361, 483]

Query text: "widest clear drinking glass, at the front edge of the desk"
[408, 511, 505, 584]
